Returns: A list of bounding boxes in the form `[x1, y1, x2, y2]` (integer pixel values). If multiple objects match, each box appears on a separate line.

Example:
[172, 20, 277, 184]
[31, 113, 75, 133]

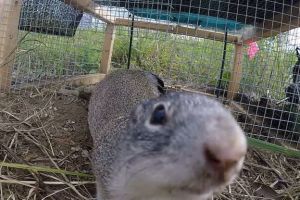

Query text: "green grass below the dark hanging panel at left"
[17, 30, 103, 75]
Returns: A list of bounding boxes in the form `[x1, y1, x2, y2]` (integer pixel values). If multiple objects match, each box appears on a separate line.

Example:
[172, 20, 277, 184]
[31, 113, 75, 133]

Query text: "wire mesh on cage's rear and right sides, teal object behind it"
[103, 1, 300, 146]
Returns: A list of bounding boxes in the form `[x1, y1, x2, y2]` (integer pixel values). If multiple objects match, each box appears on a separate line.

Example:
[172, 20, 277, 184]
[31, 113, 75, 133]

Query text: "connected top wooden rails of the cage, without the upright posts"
[65, 0, 300, 43]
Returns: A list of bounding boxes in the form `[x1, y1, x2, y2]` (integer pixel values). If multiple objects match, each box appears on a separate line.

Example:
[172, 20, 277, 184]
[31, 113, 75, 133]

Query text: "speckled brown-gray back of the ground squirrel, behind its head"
[88, 70, 164, 198]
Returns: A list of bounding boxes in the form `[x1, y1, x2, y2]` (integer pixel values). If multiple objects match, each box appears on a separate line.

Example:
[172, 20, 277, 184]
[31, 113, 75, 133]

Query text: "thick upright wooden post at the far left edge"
[0, 0, 21, 91]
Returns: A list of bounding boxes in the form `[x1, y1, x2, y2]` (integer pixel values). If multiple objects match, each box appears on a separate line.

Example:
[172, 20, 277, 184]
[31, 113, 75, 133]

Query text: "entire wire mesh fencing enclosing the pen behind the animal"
[0, 0, 300, 148]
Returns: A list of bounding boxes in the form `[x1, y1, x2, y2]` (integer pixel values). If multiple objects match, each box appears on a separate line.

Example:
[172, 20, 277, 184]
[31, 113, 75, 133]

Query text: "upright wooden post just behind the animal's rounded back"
[100, 24, 116, 74]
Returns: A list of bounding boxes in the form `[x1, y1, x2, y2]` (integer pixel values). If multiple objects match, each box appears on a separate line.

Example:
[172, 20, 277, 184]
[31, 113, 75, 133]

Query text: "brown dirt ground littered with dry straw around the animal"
[0, 88, 300, 200]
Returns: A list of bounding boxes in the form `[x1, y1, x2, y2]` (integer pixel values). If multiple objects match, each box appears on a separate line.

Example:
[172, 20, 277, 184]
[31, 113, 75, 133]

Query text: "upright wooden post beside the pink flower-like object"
[227, 44, 243, 100]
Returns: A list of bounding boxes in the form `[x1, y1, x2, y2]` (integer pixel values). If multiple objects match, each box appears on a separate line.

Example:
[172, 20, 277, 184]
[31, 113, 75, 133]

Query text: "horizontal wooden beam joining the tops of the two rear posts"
[115, 18, 242, 44]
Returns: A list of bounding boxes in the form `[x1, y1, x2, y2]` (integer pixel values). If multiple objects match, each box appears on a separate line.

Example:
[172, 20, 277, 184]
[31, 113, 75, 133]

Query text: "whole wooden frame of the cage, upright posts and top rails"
[0, 0, 300, 99]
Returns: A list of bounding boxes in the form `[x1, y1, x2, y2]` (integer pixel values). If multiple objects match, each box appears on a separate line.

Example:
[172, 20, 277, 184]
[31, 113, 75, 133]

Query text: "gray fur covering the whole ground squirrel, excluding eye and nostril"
[89, 70, 246, 200]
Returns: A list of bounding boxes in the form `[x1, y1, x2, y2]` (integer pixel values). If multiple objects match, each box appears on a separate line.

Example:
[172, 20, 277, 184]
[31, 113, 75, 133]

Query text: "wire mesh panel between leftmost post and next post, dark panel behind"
[13, 0, 108, 87]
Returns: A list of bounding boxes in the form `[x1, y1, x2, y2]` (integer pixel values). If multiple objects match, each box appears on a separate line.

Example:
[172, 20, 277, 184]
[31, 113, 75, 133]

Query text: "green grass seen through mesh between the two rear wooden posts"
[113, 30, 232, 85]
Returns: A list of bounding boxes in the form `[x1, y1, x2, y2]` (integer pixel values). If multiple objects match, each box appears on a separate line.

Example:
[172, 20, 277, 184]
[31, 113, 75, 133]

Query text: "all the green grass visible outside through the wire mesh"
[17, 28, 297, 99]
